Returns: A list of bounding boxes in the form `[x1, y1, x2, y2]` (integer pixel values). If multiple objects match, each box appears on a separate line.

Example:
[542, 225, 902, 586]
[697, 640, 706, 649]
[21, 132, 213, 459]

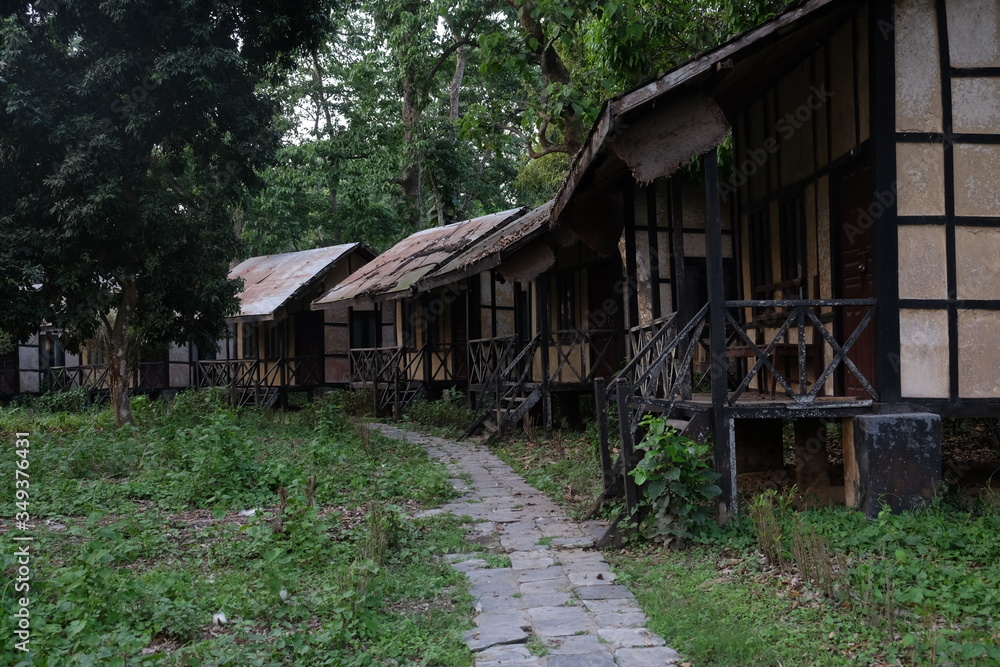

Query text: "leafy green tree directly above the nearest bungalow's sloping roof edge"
[483, 0, 789, 159]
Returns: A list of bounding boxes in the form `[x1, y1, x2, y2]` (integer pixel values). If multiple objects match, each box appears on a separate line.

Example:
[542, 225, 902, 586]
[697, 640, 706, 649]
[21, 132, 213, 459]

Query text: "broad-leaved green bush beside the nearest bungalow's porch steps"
[629, 416, 722, 544]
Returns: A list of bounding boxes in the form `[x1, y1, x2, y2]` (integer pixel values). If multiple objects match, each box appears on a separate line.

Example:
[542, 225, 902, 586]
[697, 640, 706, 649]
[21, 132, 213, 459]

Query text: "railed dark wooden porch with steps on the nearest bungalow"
[595, 299, 879, 511]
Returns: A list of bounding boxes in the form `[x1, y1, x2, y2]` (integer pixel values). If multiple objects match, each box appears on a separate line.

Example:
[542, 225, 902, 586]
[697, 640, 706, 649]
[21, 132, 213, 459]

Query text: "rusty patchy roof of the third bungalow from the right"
[313, 208, 527, 308]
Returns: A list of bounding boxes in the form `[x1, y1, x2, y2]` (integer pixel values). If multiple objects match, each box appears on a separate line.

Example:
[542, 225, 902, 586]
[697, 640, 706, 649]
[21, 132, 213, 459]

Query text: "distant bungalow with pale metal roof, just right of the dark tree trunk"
[198, 243, 374, 405]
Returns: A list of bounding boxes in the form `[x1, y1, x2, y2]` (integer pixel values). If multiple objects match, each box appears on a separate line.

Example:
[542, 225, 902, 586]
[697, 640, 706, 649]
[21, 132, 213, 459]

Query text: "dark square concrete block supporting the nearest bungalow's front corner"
[844, 413, 941, 517]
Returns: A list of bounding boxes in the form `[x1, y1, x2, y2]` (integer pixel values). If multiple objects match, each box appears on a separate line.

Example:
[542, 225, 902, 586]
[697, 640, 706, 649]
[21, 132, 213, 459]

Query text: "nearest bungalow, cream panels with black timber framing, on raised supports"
[552, 0, 1000, 515]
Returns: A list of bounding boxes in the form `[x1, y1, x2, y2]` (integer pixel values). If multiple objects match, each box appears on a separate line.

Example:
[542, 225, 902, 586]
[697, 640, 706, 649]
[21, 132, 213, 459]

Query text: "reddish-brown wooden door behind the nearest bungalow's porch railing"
[833, 160, 879, 397]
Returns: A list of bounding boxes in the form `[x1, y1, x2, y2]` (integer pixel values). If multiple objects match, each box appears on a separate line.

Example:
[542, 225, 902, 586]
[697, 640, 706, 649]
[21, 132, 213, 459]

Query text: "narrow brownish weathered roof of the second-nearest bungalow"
[417, 201, 552, 290]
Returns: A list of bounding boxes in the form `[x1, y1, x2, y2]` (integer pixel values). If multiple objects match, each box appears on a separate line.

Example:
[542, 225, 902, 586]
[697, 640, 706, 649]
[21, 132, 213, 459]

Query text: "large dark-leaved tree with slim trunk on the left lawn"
[0, 0, 330, 424]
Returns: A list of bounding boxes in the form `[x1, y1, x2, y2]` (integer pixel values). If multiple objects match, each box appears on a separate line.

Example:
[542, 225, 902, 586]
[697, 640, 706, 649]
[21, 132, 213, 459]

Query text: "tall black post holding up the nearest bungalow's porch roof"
[704, 149, 736, 521]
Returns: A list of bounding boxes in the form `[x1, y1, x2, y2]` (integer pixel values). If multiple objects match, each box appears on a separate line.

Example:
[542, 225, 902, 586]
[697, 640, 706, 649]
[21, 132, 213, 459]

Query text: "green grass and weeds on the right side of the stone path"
[500, 422, 1000, 667]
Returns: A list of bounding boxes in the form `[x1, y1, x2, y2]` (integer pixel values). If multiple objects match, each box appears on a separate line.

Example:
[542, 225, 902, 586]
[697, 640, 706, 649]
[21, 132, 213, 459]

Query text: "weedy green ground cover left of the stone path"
[0, 393, 472, 666]
